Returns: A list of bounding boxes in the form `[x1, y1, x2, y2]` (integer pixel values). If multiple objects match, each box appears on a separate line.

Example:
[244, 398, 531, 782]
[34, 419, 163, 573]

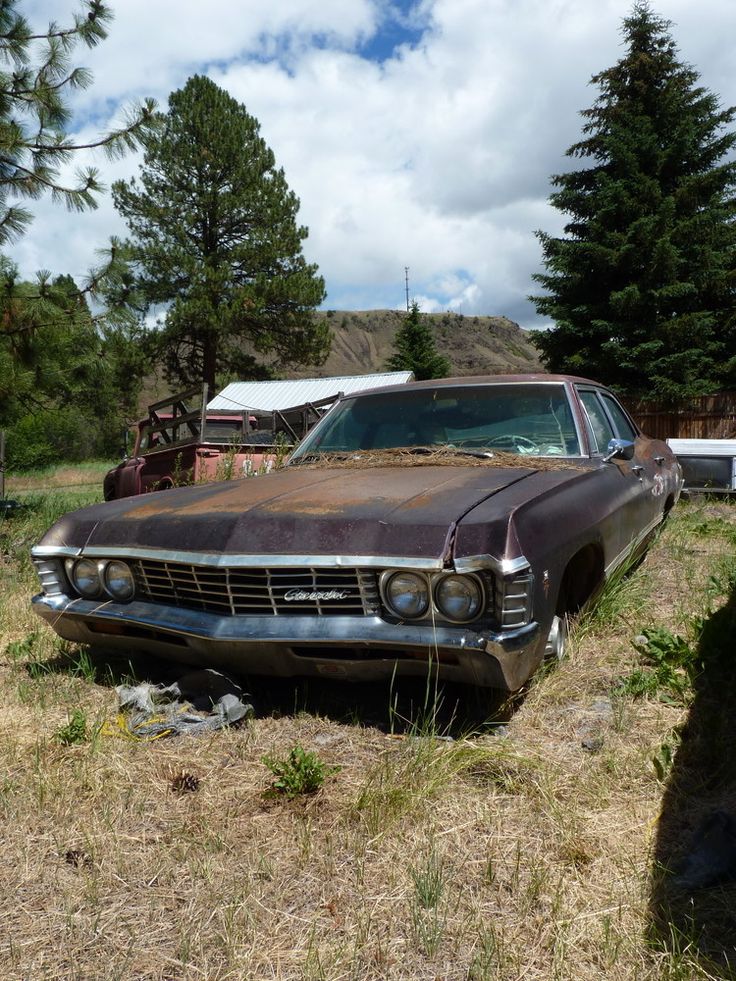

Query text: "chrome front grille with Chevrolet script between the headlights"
[132, 559, 379, 616]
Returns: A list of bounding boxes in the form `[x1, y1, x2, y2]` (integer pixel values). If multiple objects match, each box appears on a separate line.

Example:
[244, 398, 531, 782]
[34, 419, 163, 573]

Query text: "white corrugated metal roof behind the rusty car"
[207, 371, 414, 412]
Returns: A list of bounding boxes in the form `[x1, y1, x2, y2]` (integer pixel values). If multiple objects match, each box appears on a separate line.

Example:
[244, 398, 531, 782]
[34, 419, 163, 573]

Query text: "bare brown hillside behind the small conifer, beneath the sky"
[286, 310, 543, 378]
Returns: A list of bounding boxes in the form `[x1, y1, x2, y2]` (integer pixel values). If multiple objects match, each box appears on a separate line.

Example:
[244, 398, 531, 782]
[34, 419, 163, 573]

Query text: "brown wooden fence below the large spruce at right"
[625, 392, 736, 439]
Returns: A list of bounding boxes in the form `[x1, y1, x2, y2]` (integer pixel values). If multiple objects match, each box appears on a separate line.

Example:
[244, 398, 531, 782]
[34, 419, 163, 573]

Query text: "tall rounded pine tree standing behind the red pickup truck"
[113, 75, 330, 387]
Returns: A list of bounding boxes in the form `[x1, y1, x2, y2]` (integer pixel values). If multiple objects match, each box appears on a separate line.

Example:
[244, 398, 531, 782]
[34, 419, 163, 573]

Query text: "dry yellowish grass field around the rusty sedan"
[0, 467, 736, 981]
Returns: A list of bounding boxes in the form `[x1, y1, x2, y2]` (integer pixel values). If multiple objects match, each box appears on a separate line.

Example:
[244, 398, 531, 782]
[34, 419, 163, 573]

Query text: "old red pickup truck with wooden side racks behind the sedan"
[103, 389, 290, 501]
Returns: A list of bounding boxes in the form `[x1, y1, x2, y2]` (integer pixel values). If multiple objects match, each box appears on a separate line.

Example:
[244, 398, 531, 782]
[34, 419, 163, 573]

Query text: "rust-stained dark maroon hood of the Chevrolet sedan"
[40, 466, 552, 560]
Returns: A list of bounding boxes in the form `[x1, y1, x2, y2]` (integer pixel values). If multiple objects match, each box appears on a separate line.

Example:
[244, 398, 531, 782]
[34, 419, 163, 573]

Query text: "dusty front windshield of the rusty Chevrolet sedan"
[292, 383, 581, 462]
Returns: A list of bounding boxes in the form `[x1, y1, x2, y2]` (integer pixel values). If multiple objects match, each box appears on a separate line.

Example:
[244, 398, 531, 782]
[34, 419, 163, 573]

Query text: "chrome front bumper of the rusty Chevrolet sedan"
[32, 593, 543, 691]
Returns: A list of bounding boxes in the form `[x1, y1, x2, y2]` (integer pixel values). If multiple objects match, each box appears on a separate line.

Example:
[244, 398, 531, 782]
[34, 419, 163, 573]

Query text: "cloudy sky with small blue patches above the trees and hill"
[11, 0, 736, 328]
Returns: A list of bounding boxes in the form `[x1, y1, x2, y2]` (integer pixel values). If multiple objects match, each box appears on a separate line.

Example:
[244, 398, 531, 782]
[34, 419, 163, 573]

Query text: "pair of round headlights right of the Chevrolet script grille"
[381, 572, 486, 623]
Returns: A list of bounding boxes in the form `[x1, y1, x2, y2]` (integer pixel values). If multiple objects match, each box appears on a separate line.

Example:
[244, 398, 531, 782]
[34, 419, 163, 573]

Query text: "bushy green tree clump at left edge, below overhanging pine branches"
[0, 266, 150, 468]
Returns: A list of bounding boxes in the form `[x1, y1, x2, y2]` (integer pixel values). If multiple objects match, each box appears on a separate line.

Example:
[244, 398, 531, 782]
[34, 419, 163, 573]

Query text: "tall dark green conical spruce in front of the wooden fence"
[531, 2, 736, 400]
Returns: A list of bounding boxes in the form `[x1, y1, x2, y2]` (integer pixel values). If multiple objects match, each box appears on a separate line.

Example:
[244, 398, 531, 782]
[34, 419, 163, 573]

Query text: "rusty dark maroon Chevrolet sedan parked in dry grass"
[33, 374, 681, 690]
